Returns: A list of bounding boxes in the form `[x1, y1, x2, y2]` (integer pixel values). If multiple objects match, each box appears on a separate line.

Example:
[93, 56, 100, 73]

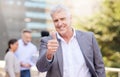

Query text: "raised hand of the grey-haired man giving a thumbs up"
[46, 32, 58, 60]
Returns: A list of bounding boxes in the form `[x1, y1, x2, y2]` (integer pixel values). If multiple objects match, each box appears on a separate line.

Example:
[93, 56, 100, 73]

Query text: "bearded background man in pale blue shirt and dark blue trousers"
[15, 29, 37, 77]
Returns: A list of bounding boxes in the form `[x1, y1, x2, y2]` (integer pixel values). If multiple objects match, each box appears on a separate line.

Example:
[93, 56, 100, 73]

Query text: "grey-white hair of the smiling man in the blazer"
[50, 4, 71, 17]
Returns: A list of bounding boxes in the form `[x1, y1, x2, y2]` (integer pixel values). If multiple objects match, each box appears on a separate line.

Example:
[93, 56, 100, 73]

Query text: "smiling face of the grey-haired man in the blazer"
[52, 11, 71, 35]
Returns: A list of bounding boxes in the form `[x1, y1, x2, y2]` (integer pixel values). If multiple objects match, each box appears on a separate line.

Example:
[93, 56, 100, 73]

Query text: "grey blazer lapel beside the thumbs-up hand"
[56, 40, 63, 77]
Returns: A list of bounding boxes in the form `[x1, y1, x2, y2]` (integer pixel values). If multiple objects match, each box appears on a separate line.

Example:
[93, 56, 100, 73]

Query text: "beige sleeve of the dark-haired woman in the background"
[7, 54, 15, 77]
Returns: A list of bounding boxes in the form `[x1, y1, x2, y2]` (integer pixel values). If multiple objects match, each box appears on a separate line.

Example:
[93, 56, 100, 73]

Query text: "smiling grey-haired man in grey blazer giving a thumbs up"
[36, 5, 105, 77]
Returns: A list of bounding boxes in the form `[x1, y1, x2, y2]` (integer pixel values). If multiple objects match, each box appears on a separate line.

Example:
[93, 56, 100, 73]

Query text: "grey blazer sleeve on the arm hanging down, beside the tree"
[92, 34, 106, 77]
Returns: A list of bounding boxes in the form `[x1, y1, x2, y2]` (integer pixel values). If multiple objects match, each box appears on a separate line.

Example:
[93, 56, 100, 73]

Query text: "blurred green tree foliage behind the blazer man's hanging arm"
[74, 0, 120, 77]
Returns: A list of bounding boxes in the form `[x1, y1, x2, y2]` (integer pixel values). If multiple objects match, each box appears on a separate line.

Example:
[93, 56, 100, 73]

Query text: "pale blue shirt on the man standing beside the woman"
[15, 39, 37, 70]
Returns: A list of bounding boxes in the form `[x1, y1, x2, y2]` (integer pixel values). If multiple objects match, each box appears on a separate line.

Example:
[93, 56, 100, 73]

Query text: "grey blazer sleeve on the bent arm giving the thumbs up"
[36, 38, 53, 72]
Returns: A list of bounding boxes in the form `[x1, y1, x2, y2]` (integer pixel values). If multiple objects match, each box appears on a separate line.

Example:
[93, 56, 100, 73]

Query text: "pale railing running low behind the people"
[0, 61, 120, 77]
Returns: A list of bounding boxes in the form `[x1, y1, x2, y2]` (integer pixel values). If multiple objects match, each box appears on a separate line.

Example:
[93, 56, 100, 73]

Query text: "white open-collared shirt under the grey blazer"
[57, 31, 91, 77]
